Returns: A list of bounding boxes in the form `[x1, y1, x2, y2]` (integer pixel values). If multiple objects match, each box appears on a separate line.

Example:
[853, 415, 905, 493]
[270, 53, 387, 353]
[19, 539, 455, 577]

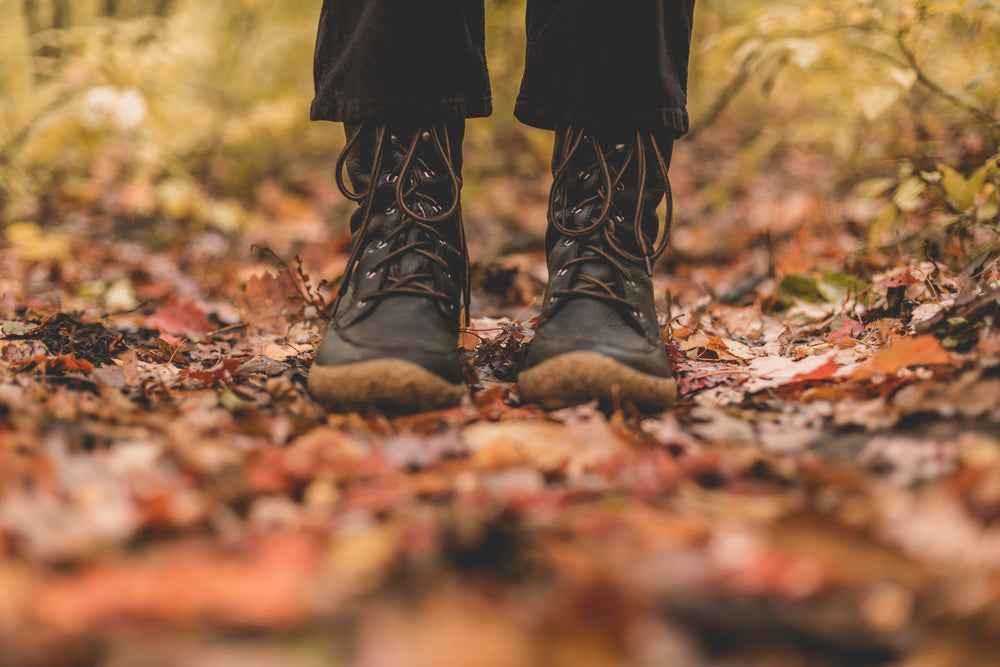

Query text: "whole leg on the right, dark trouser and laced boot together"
[515, 0, 694, 407]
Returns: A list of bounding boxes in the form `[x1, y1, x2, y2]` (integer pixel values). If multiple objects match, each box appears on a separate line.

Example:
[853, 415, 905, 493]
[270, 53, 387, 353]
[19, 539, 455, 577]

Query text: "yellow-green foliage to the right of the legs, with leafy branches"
[692, 0, 1000, 264]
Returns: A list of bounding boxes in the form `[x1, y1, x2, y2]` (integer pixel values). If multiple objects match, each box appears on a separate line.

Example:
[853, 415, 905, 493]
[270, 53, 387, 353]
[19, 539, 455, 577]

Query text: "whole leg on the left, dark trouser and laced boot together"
[309, 0, 490, 408]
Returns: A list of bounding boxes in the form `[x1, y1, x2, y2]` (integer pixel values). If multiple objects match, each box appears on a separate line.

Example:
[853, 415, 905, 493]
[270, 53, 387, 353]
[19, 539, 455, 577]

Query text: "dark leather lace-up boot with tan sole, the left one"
[309, 121, 469, 409]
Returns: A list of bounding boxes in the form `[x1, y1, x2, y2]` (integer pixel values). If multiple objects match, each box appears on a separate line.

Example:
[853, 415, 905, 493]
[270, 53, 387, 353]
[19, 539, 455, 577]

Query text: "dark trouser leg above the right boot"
[514, 0, 694, 136]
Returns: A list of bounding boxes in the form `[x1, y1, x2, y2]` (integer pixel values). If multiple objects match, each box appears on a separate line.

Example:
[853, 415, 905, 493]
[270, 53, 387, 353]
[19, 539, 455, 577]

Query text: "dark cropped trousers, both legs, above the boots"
[311, 0, 694, 136]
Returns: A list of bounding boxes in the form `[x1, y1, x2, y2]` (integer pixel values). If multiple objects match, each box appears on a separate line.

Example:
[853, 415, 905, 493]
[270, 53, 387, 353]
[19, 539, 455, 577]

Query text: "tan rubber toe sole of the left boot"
[309, 359, 468, 410]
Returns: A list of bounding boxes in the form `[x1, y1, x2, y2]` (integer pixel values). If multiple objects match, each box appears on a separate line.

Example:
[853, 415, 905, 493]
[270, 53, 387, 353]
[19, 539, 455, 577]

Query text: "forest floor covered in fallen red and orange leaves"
[0, 136, 1000, 667]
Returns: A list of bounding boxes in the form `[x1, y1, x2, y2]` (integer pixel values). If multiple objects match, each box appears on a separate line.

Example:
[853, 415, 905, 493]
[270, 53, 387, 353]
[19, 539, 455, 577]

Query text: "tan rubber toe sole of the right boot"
[517, 352, 677, 410]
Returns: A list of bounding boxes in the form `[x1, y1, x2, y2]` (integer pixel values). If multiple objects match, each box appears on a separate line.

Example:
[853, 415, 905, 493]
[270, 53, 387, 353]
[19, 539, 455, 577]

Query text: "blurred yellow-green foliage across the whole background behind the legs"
[0, 0, 1000, 262]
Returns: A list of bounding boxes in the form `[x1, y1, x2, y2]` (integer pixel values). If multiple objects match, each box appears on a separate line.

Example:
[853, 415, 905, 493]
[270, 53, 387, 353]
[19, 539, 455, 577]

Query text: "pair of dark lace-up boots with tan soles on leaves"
[309, 121, 676, 409]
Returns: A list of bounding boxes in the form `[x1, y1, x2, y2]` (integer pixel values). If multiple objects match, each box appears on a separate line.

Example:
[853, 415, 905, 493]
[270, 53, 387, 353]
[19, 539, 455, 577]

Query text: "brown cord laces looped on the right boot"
[548, 127, 673, 308]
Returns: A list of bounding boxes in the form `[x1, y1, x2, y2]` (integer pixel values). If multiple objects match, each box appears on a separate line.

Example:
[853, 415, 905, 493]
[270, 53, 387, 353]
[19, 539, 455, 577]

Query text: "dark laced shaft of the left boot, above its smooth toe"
[334, 121, 468, 328]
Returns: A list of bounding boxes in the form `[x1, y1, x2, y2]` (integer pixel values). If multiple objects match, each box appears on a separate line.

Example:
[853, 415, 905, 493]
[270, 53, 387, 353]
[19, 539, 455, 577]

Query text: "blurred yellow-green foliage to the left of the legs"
[0, 0, 326, 224]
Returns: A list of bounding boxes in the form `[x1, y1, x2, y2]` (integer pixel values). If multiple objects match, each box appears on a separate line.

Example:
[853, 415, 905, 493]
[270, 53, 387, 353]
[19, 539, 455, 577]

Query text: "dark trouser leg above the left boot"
[311, 0, 492, 123]
